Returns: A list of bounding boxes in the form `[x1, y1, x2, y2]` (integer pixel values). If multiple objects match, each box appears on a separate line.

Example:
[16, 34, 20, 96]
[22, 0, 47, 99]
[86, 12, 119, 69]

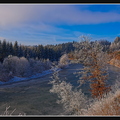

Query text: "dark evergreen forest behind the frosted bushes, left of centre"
[0, 40, 75, 62]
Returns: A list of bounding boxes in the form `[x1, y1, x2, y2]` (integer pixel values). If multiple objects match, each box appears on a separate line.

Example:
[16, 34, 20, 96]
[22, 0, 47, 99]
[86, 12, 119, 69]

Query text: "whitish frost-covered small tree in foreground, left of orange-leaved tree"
[50, 69, 87, 115]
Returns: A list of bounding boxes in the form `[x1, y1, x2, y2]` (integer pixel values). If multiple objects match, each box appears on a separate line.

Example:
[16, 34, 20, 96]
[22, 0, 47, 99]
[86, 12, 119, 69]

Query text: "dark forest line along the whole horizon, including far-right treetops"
[0, 37, 120, 62]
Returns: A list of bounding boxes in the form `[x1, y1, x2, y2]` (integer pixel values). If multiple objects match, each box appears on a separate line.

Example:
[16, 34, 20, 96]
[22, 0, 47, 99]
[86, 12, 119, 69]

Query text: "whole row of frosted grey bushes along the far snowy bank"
[3, 56, 51, 77]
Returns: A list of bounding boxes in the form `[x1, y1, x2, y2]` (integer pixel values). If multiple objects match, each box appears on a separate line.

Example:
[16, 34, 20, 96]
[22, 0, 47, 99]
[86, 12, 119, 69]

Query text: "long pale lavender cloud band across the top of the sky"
[0, 4, 120, 26]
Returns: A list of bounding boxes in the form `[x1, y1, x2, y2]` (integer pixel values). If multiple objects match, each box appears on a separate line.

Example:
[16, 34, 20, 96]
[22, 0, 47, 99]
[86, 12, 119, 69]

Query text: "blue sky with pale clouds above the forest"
[0, 3, 120, 45]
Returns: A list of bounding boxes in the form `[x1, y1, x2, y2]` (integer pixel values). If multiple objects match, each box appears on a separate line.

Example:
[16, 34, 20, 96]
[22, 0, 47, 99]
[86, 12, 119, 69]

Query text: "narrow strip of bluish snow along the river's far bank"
[0, 68, 61, 85]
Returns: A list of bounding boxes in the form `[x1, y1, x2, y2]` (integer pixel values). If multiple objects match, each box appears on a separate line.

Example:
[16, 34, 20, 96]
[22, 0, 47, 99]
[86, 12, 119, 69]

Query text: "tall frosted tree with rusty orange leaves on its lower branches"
[74, 36, 110, 98]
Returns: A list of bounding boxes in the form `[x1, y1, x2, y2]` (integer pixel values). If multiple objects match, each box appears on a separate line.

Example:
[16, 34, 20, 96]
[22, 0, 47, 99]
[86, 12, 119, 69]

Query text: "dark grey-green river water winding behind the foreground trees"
[0, 64, 120, 115]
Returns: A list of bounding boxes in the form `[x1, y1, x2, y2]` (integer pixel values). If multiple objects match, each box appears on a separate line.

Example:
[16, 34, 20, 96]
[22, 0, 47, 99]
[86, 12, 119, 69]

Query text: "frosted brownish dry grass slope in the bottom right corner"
[84, 89, 120, 116]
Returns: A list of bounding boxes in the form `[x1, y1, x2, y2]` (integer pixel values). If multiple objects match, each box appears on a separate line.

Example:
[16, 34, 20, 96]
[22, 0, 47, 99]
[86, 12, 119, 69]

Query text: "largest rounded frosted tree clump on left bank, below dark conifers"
[3, 55, 30, 77]
